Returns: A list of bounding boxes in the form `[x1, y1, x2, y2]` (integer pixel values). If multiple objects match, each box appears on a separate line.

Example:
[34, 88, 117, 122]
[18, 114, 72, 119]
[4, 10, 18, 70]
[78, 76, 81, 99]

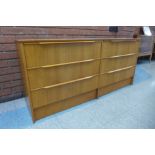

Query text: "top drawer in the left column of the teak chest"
[24, 41, 101, 68]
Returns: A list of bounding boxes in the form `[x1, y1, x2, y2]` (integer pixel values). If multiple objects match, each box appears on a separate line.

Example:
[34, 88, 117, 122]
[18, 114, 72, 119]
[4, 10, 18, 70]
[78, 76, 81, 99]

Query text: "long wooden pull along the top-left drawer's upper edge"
[39, 41, 96, 45]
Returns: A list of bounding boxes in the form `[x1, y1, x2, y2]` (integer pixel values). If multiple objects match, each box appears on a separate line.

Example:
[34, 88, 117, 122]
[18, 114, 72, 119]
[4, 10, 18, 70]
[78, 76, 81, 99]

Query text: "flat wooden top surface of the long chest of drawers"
[16, 38, 140, 43]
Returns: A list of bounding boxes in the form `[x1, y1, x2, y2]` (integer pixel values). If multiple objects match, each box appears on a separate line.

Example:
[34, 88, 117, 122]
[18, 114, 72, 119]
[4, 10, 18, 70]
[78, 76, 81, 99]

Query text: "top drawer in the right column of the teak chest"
[101, 40, 139, 58]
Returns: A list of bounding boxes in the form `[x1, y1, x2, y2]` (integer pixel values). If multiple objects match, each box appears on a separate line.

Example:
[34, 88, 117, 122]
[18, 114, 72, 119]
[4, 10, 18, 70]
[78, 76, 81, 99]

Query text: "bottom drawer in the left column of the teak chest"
[31, 75, 98, 108]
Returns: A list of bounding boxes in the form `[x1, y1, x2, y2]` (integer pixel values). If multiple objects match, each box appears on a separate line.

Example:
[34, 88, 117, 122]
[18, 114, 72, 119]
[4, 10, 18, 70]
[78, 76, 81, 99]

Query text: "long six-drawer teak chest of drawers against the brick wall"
[17, 39, 139, 121]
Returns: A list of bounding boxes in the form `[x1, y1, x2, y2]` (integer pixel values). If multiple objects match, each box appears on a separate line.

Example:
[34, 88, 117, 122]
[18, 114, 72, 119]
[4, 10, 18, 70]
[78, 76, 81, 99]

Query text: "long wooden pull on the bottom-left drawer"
[43, 74, 98, 89]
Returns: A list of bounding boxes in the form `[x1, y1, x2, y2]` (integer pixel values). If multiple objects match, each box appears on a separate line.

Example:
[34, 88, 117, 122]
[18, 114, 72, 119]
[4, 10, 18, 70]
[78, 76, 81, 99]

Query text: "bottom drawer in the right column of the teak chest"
[99, 66, 135, 87]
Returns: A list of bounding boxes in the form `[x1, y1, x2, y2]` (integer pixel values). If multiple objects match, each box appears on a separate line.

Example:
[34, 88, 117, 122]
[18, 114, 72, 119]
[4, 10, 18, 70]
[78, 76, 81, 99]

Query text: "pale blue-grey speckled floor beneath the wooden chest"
[0, 61, 155, 129]
